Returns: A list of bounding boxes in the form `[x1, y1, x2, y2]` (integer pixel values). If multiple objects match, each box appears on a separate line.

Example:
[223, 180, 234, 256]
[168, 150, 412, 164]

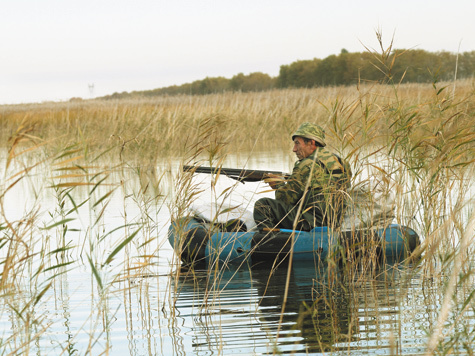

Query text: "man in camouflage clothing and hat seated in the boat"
[254, 122, 352, 231]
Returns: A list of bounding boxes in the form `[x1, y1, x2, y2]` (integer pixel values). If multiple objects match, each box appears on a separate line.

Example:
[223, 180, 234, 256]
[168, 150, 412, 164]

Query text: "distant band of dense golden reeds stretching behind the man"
[0, 80, 475, 160]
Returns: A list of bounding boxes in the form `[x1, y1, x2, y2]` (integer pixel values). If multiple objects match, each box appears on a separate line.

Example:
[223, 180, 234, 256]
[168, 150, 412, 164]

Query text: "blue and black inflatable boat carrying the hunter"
[168, 217, 420, 264]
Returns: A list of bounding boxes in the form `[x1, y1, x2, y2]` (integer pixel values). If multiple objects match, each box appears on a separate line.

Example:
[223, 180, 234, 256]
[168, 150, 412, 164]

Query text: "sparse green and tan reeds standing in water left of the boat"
[0, 125, 173, 355]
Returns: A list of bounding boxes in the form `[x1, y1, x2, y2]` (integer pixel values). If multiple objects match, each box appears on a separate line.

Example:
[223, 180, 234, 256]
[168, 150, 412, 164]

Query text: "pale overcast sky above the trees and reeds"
[0, 0, 475, 104]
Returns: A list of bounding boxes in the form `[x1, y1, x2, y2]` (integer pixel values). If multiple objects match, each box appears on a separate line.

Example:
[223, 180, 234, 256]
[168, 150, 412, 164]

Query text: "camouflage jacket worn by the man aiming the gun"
[275, 147, 352, 226]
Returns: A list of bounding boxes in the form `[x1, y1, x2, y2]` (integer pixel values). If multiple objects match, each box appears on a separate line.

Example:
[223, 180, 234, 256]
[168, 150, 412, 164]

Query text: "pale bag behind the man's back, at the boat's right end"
[341, 178, 395, 231]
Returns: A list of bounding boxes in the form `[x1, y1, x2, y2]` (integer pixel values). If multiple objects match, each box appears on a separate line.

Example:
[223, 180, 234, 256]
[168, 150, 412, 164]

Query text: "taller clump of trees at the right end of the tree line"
[277, 49, 475, 88]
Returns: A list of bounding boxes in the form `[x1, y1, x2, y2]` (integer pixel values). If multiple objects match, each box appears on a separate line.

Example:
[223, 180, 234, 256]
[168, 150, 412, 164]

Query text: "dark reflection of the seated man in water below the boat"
[256, 263, 352, 352]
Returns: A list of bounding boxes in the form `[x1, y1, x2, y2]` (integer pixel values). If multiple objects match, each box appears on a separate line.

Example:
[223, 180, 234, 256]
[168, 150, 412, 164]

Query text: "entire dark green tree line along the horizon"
[103, 49, 475, 99]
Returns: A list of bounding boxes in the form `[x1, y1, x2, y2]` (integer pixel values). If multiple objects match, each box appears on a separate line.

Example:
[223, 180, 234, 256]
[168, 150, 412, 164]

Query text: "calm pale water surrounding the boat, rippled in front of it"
[0, 152, 475, 355]
